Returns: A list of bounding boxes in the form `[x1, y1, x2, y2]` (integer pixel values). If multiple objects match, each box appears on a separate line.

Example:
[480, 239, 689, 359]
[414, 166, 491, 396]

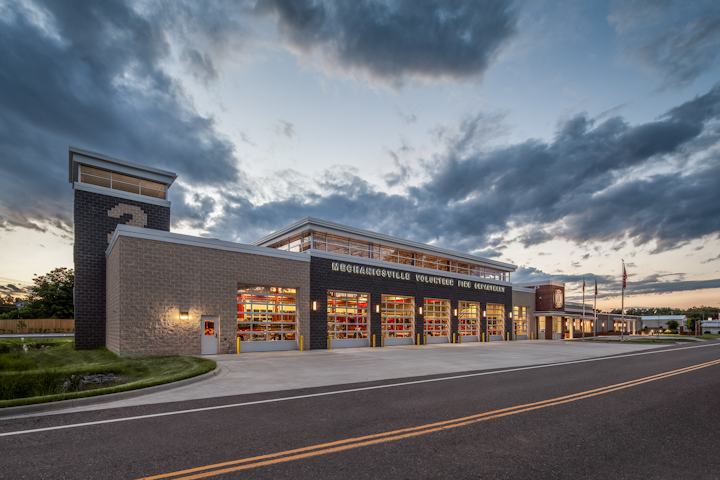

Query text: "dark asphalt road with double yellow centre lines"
[0, 341, 720, 479]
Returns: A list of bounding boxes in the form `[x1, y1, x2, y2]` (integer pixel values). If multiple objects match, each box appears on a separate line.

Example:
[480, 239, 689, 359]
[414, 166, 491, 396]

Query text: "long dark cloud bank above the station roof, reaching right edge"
[184, 84, 720, 259]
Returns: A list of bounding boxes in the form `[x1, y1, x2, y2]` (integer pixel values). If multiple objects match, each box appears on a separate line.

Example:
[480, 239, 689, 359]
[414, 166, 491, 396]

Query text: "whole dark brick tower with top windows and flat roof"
[69, 147, 177, 349]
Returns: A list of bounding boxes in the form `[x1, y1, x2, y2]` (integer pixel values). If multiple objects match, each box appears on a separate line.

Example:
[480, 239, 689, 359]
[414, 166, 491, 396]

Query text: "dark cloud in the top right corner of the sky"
[608, 0, 720, 87]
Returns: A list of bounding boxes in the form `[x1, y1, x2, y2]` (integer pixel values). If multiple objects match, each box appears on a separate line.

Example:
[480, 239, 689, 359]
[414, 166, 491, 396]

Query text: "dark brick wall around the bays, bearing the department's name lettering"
[306, 257, 512, 349]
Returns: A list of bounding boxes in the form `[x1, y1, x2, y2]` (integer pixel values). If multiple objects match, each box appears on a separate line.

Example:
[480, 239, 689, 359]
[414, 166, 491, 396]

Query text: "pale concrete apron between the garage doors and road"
[38, 340, 659, 413]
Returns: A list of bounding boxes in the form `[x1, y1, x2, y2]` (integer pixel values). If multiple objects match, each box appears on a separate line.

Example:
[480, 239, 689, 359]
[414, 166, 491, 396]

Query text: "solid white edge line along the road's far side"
[0, 343, 720, 437]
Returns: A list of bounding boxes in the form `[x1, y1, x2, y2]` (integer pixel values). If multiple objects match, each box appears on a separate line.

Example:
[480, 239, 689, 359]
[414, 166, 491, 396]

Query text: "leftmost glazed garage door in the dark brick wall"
[327, 292, 368, 340]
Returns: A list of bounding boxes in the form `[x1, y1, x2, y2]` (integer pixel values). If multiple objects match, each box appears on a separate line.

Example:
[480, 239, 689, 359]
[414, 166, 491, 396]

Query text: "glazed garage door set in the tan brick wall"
[237, 285, 297, 342]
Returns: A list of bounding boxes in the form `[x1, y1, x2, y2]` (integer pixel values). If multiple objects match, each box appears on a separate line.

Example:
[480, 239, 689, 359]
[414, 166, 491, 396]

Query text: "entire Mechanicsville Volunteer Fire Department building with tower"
[69, 147, 634, 355]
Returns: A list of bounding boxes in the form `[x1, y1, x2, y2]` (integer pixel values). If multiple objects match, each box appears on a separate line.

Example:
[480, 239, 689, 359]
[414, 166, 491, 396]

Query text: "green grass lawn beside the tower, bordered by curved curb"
[0, 338, 215, 408]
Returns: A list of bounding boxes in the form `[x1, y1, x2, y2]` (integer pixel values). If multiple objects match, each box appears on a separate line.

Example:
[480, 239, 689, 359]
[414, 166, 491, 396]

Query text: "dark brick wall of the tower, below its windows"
[73, 190, 170, 349]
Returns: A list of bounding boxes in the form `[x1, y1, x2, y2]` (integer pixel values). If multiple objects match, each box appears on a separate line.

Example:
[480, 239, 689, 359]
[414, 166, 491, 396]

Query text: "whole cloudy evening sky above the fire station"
[0, 0, 720, 308]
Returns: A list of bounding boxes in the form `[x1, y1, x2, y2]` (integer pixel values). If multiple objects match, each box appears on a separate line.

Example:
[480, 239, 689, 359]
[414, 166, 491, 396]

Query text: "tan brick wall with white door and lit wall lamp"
[107, 236, 310, 356]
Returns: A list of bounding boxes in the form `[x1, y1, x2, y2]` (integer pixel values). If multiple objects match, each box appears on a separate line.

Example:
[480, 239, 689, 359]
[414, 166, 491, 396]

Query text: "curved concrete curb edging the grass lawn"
[0, 364, 220, 418]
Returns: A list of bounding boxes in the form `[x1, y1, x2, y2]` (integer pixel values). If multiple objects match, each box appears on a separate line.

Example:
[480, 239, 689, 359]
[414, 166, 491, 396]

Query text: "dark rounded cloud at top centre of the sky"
[258, 0, 517, 86]
